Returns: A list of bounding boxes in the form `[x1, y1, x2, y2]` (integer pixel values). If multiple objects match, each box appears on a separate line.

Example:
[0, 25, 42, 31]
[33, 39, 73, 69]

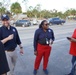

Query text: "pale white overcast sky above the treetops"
[0, 0, 76, 12]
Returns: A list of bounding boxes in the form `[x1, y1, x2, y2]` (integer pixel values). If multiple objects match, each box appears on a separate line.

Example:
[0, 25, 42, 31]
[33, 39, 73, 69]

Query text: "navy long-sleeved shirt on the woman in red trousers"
[34, 28, 55, 51]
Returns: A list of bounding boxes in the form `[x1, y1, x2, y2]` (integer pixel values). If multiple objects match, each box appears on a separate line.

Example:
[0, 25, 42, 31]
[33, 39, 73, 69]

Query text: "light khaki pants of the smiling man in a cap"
[5, 50, 17, 75]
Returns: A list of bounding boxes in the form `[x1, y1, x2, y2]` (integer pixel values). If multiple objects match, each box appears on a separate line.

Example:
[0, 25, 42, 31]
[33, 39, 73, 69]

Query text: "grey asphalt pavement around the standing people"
[6, 22, 76, 75]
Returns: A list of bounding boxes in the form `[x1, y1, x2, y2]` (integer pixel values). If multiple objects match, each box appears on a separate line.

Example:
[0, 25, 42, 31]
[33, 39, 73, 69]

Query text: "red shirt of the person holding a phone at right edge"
[69, 29, 76, 56]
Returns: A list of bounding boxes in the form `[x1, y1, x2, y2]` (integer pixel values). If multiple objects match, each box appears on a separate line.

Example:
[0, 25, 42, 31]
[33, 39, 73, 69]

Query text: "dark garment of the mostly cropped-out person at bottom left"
[0, 41, 9, 75]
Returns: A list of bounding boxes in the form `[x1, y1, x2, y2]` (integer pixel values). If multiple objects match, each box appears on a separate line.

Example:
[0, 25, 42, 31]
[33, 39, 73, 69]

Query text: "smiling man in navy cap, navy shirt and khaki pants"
[0, 14, 23, 75]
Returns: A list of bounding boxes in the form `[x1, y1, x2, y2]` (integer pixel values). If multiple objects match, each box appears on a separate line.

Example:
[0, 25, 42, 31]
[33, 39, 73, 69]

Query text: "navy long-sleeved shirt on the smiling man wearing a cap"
[0, 26, 21, 50]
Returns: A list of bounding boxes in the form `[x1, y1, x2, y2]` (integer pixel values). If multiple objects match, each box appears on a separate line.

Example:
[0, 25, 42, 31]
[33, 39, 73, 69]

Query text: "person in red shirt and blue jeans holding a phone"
[67, 29, 76, 75]
